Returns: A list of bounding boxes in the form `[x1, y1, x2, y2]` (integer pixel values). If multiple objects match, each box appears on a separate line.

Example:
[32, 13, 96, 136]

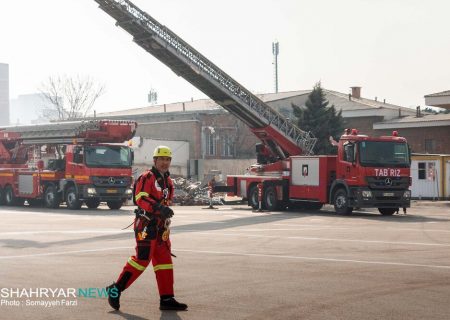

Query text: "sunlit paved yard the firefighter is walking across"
[0, 202, 450, 320]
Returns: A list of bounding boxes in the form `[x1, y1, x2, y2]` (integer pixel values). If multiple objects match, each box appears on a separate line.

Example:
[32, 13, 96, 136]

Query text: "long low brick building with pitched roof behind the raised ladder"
[98, 87, 450, 178]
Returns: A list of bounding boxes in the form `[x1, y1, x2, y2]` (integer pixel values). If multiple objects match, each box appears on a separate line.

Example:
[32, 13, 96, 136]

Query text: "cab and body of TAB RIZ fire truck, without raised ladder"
[227, 129, 411, 215]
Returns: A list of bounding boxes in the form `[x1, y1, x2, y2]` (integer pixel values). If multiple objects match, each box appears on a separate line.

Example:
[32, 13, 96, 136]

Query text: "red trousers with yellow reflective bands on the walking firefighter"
[116, 218, 174, 296]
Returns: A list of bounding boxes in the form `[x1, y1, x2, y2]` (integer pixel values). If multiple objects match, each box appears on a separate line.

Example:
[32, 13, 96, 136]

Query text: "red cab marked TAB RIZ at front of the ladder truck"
[330, 129, 411, 215]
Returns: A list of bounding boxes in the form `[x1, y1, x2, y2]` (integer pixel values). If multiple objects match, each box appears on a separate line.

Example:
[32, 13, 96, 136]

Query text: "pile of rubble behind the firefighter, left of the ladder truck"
[172, 177, 225, 206]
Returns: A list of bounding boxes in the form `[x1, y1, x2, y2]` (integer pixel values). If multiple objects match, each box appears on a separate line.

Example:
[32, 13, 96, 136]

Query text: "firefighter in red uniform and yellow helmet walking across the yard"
[107, 146, 187, 310]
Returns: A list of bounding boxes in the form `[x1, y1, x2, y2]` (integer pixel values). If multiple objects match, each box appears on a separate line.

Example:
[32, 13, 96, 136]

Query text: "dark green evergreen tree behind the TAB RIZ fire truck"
[292, 82, 344, 154]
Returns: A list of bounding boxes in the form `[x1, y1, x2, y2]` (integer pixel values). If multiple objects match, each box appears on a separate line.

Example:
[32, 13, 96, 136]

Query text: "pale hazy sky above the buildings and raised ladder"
[0, 0, 450, 112]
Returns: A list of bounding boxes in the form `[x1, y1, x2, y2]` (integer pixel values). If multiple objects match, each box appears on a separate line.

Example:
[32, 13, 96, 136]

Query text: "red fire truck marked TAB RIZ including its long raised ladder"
[95, 0, 411, 215]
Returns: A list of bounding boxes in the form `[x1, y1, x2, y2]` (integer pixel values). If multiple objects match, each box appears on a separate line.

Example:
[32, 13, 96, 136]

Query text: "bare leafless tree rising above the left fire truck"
[39, 75, 105, 120]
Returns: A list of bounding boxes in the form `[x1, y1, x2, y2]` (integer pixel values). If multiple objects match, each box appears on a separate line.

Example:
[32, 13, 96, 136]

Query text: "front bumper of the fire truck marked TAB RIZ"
[349, 188, 411, 208]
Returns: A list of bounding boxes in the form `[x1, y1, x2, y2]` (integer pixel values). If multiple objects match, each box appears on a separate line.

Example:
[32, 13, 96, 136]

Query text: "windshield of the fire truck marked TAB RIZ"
[359, 141, 410, 168]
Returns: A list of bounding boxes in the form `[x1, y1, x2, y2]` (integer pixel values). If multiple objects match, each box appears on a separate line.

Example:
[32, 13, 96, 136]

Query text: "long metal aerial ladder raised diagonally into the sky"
[95, 0, 316, 159]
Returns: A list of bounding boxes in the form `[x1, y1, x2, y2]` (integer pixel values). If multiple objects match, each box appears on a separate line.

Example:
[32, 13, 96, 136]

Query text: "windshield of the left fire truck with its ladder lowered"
[85, 146, 131, 168]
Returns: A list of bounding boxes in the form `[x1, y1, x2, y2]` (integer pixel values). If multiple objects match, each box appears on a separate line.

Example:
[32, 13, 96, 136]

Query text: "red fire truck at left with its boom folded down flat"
[0, 120, 137, 210]
